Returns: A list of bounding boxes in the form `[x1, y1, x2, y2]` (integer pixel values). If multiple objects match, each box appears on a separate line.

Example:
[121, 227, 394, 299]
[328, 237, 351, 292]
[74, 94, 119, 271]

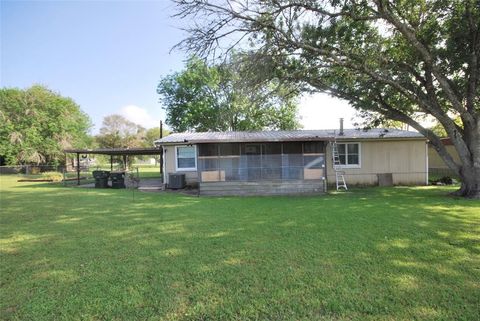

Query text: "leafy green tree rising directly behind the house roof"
[157, 57, 299, 131]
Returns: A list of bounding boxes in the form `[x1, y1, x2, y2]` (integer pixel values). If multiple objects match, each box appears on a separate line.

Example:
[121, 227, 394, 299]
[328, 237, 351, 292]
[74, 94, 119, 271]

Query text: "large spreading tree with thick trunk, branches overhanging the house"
[176, 0, 480, 198]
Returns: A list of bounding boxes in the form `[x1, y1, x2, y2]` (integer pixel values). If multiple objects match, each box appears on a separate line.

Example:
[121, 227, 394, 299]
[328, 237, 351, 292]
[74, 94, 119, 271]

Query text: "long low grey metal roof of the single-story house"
[155, 128, 426, 145]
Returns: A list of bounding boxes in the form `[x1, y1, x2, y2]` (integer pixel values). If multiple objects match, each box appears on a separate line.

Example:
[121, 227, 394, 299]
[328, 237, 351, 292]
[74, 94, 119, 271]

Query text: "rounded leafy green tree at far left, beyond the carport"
[0, 85, 91, 165]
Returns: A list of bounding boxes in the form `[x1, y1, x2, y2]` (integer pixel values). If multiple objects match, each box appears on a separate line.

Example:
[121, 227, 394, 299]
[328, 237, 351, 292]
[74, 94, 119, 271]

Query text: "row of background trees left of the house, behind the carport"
[0, 85, 168, 165]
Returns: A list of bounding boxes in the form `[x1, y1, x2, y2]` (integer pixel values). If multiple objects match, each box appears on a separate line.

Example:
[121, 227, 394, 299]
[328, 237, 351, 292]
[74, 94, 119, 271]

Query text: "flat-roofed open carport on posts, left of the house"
[64, 147, 163, 185]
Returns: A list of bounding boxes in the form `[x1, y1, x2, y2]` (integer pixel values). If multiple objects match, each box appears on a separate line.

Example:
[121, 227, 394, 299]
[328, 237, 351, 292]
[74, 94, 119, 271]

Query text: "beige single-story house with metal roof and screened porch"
[155, 129, 428, 195]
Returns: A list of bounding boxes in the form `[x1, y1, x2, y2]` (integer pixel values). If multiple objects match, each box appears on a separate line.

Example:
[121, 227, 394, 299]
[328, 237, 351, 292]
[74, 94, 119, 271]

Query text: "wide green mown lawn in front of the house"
[0, 176, 480, 321]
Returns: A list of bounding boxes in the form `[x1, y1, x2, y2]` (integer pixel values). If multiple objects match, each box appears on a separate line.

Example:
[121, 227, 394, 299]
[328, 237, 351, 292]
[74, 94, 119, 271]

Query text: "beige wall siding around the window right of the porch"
[326, 140, 427, 185]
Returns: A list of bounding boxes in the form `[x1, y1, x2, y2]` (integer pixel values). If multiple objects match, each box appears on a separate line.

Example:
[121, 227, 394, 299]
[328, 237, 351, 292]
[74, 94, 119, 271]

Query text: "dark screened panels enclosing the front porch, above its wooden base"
[197, 142, 325, 183]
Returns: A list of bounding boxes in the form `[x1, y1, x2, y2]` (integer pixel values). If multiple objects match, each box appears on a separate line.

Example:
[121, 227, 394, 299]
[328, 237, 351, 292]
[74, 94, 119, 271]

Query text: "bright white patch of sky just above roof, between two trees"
[299, 94, 355, 129]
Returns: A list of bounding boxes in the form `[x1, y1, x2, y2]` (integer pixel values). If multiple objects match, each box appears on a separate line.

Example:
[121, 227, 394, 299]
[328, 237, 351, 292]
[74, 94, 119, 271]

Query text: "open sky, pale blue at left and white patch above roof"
[0, 0, 354, 134]
